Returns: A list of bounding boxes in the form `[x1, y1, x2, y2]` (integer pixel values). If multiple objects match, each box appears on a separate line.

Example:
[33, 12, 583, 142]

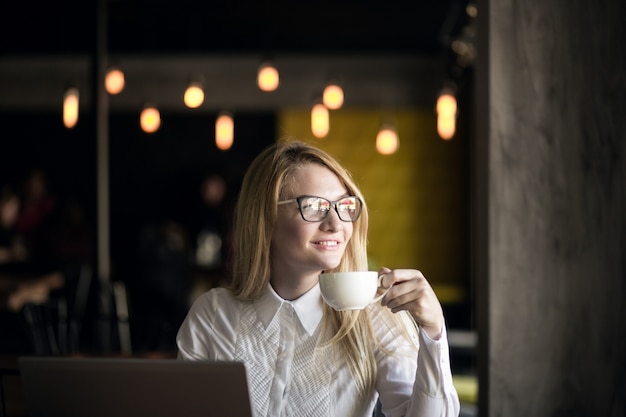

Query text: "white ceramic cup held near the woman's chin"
[319, 271, 388, 310]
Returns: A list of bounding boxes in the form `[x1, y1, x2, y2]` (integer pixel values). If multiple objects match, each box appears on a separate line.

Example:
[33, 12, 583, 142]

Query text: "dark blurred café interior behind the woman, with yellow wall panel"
[0, 0, 477, 390]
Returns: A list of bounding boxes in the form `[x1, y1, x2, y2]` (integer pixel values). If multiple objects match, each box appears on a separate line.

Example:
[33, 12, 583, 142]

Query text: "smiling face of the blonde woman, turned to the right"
[271, 164, 353, 276]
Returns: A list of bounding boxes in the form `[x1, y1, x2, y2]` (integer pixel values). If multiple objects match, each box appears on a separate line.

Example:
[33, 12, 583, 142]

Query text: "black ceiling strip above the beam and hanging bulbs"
[0, 0, 468, 56]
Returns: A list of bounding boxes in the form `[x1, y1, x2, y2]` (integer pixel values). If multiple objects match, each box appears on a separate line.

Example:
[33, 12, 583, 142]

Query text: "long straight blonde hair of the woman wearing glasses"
[231, 140, 414, 397]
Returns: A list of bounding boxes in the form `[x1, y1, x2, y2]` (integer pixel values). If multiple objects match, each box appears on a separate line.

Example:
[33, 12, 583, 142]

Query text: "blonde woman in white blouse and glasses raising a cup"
[177, 141, 459, 417]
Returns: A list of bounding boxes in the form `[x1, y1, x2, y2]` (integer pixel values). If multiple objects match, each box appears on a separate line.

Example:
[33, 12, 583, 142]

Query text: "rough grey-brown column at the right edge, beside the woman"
[473, 0, 626, 417]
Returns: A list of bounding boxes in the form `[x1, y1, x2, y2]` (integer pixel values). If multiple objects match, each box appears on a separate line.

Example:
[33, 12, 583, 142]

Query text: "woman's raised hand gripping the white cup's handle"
[379, 268, 444, 340]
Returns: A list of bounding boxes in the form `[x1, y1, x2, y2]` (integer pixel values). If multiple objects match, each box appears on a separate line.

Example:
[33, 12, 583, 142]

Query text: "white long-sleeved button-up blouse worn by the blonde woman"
[177, 285, 460, 417]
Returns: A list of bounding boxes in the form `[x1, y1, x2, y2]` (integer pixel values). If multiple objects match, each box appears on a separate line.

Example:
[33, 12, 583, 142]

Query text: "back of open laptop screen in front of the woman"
[19, 356, 252, 417]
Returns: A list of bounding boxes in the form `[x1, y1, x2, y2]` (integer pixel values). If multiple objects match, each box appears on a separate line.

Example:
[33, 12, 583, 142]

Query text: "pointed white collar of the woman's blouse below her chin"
[255, 284, 323, 336]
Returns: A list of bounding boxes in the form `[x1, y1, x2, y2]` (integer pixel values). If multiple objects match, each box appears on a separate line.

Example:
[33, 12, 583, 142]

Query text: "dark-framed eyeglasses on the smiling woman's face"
[276, 195, 363, 222]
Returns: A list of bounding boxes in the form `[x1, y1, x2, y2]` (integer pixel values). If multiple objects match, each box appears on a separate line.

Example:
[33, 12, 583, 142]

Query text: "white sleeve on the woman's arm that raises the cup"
[376, 308, 460, 417]
